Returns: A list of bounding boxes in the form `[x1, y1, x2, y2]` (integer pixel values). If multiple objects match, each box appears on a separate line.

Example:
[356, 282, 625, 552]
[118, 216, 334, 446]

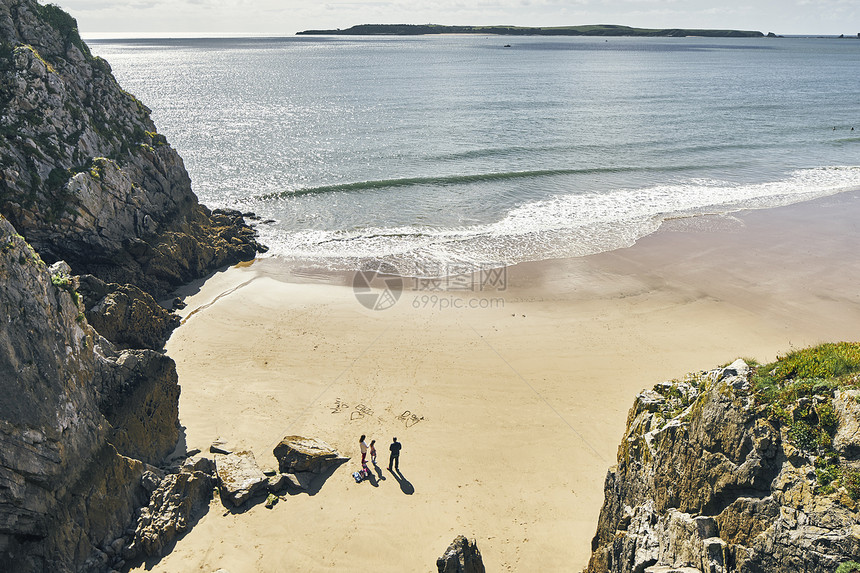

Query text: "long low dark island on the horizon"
[296, 24, 764, 38]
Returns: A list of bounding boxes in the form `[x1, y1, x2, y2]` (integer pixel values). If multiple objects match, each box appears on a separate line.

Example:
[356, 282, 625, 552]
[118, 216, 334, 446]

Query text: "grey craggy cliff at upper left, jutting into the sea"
[0, 0, 260, 296]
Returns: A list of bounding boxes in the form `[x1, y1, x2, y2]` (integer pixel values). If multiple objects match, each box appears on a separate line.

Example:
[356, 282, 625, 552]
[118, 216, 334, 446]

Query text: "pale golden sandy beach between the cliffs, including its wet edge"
[138, 193, 860, 573]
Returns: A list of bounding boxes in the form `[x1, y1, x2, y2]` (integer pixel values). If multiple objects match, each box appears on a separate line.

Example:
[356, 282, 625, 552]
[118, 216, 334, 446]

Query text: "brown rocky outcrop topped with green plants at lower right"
[588, 343, 860, 573]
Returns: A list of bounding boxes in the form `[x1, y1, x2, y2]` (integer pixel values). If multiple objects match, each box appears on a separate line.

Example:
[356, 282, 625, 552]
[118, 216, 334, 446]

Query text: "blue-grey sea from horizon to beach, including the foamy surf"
[90, 36, 860, 274]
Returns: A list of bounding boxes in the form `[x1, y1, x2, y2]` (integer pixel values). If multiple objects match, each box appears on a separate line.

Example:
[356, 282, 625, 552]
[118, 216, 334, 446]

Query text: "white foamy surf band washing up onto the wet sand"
[255, 167, 860, 274]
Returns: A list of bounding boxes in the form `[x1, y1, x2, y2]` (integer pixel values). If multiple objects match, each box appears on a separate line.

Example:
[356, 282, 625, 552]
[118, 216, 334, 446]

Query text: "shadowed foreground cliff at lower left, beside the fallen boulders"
[0, 217, 179, 571]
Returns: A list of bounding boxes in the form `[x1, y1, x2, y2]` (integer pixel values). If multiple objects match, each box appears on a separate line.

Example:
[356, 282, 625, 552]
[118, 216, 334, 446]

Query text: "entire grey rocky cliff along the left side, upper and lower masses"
[0, 0, 261, 573]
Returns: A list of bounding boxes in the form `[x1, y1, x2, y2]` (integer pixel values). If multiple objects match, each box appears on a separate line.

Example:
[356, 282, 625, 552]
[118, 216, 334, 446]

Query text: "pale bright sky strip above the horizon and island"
[55, 0, 860, 37]
